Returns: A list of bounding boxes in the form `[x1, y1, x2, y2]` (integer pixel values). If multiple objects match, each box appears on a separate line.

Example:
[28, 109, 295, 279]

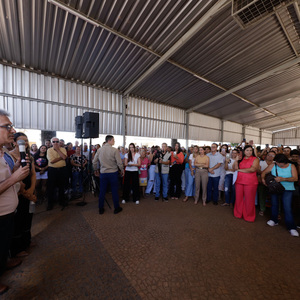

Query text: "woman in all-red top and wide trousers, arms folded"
[233, 145, 259, 222]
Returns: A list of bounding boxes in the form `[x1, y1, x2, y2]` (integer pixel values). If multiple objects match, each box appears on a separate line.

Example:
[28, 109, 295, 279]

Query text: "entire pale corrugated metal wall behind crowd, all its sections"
[0, 64, 272, 144]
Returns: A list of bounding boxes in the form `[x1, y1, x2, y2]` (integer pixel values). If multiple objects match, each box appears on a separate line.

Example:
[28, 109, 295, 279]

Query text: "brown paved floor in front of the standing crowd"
[1, 195, 300, 300]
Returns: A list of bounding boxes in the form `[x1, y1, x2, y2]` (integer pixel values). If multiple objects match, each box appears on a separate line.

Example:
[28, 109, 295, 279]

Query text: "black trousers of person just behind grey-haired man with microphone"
[10, 195, 33, 257]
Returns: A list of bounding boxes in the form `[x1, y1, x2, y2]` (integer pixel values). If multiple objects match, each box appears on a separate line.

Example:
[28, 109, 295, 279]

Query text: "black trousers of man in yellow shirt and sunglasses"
[47, 167, 68, 207]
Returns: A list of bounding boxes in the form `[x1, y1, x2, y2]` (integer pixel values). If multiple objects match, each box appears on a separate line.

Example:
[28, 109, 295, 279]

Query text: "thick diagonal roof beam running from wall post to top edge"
[124, 0, 228, 95]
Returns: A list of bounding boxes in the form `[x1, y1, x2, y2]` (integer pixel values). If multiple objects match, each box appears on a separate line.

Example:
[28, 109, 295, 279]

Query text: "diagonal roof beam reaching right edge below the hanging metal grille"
[187, 57, 300, 116]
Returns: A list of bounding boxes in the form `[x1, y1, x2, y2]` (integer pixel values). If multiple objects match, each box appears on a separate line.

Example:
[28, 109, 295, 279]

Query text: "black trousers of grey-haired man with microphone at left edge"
[0, 213, 14, 276]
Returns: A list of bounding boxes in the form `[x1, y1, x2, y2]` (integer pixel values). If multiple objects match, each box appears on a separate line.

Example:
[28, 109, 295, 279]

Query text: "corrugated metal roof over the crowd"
[0, 0, 300, 130]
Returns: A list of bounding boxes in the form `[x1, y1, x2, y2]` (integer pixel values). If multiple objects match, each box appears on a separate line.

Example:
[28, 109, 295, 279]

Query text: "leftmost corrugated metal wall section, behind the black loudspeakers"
[0, 64, 122, 134]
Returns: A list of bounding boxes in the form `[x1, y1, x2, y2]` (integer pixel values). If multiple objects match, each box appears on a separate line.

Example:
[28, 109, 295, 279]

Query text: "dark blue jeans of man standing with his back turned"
[99, 172, 120, 209]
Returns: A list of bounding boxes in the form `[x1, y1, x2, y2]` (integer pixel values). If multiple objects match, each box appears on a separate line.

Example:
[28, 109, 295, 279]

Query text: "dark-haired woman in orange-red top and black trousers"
[169, 143, 184, 199]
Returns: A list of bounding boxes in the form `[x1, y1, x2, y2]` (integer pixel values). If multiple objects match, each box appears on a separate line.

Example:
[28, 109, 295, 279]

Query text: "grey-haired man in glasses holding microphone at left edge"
[0, 110, 29, 295]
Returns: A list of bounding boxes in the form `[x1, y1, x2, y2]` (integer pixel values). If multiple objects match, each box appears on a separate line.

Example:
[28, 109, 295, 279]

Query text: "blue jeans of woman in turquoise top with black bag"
[271, 191, 296, 230]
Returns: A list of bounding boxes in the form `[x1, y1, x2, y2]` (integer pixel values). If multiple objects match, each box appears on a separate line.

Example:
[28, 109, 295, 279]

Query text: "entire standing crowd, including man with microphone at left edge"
[0, 106, 300, 295]
